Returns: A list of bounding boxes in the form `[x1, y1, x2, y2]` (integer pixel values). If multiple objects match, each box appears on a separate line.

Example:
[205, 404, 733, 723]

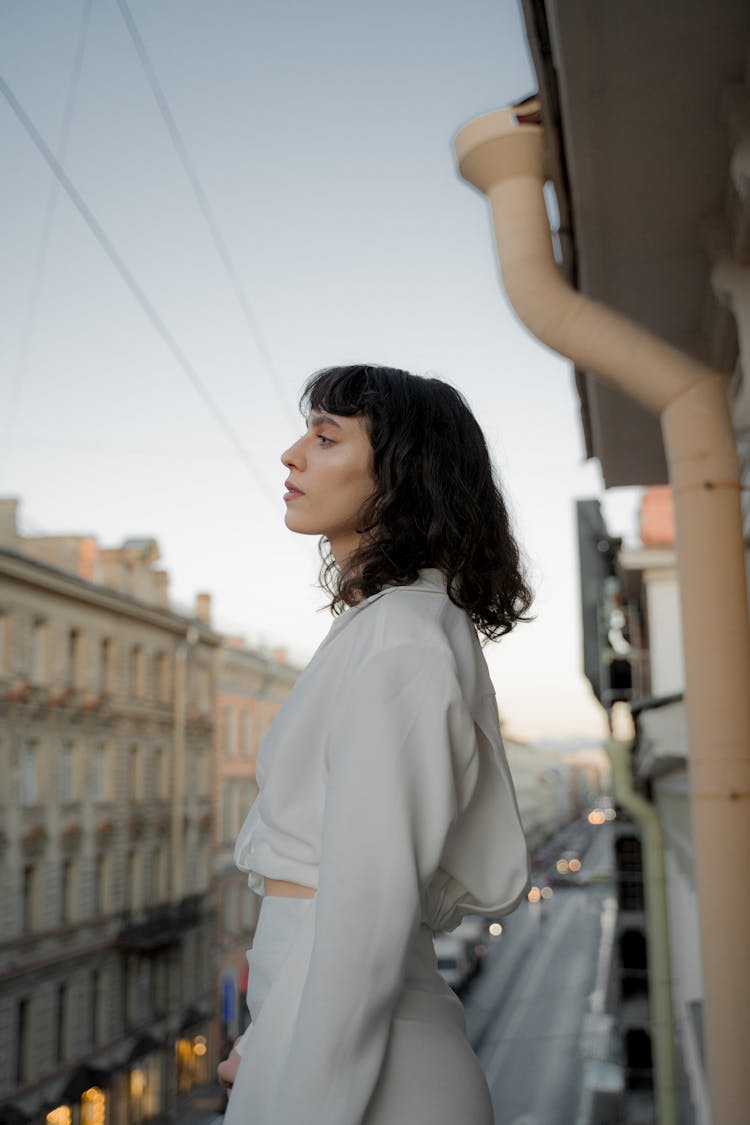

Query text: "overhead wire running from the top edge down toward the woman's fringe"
[117, 0, 299, 426]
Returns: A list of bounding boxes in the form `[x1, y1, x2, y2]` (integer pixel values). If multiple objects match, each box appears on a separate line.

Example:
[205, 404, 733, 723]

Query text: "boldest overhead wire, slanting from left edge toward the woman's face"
[0, 74, 278, 509]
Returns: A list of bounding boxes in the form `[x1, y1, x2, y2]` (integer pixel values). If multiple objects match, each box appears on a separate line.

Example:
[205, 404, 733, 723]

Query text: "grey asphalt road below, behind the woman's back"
[462, 825, 612, 1125]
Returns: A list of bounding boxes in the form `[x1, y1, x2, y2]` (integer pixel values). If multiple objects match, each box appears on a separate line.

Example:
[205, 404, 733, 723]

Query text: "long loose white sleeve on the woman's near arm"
[273, 645, 476, 1125]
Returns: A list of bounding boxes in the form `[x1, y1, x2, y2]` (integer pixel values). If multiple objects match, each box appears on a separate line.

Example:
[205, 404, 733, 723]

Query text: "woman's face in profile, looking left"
[281, 411, 376, 564]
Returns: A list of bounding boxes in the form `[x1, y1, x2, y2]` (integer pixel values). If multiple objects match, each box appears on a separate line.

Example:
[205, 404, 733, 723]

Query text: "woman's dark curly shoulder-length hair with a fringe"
[300, 365, 533, 640]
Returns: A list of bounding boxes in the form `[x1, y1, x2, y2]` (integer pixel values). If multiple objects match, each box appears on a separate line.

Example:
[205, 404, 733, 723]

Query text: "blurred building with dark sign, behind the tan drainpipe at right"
[578, 495, 692, 1122]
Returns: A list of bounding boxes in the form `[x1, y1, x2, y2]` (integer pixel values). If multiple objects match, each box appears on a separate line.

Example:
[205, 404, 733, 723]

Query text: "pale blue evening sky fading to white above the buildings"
[0, 0, 640, 740]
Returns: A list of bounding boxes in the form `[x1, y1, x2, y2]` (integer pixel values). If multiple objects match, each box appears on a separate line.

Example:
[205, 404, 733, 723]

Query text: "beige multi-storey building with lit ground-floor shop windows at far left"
[0, 500, 219, 1125]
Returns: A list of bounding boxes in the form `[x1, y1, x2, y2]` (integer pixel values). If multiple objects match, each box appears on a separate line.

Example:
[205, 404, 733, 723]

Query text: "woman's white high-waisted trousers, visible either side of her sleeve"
[224, 896, 494, 1125]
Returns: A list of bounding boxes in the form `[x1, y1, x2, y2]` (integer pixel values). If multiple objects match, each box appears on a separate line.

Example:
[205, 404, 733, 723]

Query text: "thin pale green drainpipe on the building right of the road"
[605, 739, 679, 1125]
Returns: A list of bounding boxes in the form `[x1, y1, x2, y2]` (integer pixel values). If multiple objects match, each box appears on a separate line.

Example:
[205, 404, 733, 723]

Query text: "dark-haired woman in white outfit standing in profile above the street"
[219, 366, 531, 1125]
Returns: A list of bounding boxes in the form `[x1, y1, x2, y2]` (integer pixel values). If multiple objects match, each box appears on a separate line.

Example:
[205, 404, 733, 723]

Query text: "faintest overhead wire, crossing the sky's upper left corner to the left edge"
[0, 0, 93, 479]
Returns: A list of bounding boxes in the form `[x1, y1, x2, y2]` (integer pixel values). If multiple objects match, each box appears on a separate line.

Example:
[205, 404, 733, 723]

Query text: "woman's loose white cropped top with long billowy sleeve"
[234, 569, 530, 1125]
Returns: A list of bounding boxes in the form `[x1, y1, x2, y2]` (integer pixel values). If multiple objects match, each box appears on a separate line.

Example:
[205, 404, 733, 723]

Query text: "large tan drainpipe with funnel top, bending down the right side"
[455, 102, 750, 1125]
